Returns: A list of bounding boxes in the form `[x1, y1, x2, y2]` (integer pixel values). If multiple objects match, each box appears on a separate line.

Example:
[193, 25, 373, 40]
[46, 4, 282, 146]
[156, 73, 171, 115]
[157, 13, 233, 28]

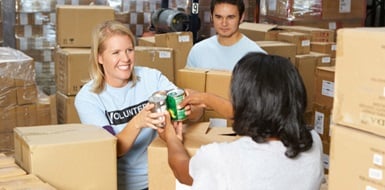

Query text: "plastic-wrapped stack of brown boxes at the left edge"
[0, 47, 56, 152]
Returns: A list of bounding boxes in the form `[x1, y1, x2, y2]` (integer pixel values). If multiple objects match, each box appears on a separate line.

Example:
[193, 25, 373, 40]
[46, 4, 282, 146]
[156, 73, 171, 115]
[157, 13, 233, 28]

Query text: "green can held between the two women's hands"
[166, 88, 187, 121]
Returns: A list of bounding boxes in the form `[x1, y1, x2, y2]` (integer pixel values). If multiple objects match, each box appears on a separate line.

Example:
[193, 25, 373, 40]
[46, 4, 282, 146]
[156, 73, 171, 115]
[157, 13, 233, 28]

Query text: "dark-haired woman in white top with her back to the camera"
[158, 52, 324, 190]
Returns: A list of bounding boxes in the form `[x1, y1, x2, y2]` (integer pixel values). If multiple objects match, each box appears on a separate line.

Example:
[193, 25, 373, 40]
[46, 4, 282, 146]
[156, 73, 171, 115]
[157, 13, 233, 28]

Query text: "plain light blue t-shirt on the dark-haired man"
[186, 35, 266, 71]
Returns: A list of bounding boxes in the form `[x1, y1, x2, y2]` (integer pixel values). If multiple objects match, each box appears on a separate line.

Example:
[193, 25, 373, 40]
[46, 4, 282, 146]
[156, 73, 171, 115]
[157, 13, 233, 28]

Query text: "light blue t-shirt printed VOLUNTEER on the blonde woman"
[75, 67, 176, 190]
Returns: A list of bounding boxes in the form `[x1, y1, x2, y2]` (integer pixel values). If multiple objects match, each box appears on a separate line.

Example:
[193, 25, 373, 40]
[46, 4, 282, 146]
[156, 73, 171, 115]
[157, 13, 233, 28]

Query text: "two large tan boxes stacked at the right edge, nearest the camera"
[329, 28, 385, 190]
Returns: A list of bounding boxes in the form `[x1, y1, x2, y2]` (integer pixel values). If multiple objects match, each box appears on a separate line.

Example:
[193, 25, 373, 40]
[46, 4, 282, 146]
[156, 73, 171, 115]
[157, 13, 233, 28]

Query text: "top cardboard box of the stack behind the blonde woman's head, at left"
[56, 5, 115, 47]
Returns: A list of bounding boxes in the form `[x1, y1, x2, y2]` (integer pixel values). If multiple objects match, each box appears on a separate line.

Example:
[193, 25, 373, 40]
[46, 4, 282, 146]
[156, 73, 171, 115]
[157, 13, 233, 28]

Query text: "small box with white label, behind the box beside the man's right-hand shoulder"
[278, 32, 311, 54]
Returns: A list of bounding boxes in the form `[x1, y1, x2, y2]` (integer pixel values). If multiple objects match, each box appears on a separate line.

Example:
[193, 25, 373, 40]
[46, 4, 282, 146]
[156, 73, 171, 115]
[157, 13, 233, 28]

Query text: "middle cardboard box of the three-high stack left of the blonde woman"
[55, 48, 91, 95]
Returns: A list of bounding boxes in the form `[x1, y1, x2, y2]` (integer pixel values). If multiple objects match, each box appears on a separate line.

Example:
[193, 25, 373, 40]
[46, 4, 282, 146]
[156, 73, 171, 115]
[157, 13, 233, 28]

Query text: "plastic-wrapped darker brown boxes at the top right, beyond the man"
[260, 0, 367, 30]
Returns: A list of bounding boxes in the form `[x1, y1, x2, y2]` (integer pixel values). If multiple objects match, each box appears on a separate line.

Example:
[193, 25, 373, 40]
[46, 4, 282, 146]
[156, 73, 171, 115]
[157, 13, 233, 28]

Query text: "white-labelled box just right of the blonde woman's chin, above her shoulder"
[135, 46, 175, 82]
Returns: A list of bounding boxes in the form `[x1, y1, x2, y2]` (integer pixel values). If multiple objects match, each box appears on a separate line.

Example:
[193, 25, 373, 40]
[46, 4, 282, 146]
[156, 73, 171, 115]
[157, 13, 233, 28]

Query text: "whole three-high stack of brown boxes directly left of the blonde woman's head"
[55, 5, 114, 124]
